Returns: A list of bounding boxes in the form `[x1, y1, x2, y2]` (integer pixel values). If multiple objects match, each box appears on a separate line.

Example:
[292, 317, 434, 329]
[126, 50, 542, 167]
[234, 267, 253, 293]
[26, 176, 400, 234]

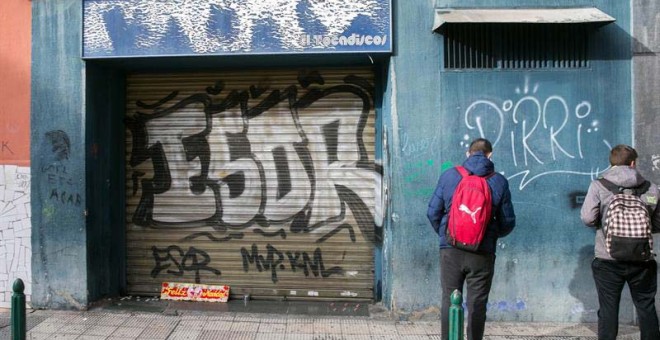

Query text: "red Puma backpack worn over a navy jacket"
[446, 166, 493, 251]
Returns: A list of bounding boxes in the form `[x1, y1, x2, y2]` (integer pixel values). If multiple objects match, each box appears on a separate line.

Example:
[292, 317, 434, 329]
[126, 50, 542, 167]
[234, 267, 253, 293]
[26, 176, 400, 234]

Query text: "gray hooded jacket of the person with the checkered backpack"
[580, 166, 660, 260]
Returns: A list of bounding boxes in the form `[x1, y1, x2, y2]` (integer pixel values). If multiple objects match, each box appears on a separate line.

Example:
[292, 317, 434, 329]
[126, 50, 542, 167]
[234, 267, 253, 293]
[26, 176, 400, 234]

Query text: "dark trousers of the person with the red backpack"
[440, 248, 495, 340]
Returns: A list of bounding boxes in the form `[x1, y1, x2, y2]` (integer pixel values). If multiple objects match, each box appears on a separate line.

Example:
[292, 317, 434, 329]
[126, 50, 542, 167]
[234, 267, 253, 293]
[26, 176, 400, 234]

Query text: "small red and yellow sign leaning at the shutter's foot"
[160, 282, 229, 302]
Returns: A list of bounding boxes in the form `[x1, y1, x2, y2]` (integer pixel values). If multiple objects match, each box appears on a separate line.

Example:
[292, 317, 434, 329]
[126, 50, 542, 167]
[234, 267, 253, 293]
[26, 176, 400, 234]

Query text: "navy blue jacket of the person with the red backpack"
[427, 152, 516, 253]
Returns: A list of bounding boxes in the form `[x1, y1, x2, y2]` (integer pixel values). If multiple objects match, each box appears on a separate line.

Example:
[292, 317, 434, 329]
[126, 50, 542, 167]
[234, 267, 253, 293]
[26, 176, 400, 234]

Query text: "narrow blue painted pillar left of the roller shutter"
[30, 0, 88, 309]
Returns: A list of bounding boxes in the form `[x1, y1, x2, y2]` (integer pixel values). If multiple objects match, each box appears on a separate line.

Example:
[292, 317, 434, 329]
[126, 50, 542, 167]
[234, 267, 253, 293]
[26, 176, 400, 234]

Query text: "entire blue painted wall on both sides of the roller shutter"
[31, 0, 644, 321]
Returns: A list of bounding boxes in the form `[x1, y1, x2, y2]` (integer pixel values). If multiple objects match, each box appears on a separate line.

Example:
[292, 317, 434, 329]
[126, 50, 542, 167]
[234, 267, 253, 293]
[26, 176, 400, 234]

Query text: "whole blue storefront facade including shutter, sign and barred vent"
[31, 0, 652, 321]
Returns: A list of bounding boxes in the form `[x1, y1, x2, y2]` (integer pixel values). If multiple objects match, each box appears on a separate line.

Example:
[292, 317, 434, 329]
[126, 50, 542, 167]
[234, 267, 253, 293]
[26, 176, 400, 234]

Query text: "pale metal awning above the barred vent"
[433, 7, 616, 31]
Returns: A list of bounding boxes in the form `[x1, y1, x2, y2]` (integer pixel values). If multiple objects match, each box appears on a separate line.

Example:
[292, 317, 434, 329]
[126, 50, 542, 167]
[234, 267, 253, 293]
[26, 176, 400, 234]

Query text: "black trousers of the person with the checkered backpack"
[591, 258, 660, 340]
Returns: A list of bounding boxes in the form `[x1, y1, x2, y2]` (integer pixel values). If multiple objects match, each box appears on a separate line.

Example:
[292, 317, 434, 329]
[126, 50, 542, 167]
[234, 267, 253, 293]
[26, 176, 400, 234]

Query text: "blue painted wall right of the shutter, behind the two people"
[384, 0, 633, 321]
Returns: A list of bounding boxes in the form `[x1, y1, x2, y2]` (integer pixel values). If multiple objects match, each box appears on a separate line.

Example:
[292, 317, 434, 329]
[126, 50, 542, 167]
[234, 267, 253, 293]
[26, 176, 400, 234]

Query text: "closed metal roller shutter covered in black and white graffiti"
[125, 69, 381, 300]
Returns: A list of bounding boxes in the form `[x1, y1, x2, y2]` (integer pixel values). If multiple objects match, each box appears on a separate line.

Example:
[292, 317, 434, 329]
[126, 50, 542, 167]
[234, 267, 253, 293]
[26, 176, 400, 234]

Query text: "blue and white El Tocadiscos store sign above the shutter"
[83, 0, 392, 58]
